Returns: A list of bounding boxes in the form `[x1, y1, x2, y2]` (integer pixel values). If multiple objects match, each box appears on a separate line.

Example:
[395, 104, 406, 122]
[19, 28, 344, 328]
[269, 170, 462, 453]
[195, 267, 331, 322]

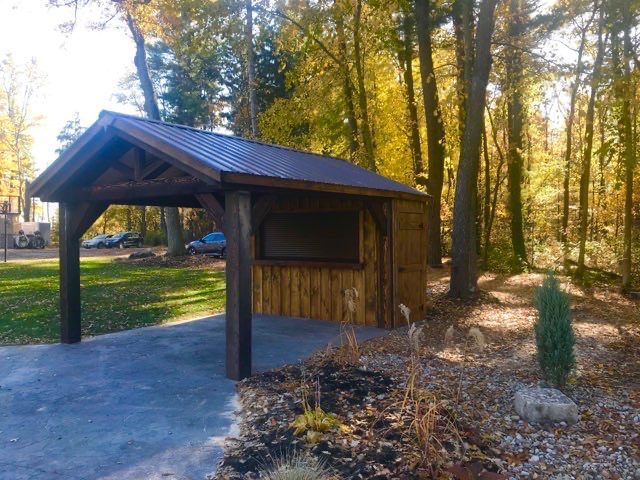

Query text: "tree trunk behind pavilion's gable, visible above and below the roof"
[127, 15, 185, 256]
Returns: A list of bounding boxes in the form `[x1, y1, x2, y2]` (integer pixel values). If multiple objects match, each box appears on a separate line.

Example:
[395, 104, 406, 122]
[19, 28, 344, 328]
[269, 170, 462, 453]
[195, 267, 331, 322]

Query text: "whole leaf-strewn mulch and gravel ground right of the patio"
[215, 275, 640, 480]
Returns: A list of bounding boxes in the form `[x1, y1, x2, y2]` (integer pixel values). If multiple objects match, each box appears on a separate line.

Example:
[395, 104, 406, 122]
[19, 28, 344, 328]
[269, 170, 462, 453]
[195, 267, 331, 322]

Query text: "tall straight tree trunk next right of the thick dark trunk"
[505, 0, 527, 268]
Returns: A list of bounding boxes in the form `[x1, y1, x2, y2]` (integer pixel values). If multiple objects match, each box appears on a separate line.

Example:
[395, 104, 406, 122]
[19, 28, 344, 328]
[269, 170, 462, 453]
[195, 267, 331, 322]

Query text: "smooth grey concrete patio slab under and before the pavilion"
[0, 315, 385, 480]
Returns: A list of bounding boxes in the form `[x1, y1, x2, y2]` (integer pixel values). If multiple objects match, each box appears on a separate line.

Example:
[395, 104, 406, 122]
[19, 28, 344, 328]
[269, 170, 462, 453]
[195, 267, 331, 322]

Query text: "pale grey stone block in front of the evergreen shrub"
[514, 387, 578, 424]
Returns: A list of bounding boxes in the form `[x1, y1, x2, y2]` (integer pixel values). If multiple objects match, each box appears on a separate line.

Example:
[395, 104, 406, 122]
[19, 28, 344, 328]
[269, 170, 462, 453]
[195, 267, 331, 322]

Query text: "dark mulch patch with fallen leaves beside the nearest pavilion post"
[216, 353, 504, 480]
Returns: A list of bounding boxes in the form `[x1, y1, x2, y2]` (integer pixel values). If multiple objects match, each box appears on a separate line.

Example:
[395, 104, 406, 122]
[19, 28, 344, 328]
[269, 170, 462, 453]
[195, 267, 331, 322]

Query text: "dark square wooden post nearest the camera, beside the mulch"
[225, 192, 252, 380]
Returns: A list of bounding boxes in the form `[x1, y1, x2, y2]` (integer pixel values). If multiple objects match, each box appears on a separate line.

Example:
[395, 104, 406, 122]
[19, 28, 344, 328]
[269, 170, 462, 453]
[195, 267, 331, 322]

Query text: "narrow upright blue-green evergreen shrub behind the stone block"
[535, 274, 576, 387]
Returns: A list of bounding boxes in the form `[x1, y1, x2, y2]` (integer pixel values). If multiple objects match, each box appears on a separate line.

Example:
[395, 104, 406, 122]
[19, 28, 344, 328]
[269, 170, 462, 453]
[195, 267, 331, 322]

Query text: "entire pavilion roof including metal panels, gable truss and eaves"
[30, 112, 427, 207]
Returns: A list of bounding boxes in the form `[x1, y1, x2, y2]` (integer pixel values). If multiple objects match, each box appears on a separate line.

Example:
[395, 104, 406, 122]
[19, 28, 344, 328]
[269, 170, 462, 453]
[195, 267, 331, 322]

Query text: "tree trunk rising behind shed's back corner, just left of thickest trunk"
[415, 0, 446, 267]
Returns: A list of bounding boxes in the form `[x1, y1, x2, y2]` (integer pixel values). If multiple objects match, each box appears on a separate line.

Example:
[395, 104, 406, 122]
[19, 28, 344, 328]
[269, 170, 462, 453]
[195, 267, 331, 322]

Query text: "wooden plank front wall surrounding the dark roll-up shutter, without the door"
[253, 197, 379, 326]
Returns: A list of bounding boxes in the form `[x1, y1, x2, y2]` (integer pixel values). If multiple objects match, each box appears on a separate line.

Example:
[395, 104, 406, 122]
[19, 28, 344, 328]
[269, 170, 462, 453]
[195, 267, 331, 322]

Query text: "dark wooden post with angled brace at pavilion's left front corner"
[58, 203, 107, 343]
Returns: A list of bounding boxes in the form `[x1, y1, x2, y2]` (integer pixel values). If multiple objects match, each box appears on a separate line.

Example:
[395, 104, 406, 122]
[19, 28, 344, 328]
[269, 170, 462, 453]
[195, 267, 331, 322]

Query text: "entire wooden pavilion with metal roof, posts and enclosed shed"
[31, 111, 427, 380]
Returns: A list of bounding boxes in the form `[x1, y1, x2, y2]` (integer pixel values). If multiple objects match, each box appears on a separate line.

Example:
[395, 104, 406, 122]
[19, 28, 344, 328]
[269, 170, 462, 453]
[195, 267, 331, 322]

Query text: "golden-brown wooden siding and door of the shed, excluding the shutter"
[253, 195, 426, 328]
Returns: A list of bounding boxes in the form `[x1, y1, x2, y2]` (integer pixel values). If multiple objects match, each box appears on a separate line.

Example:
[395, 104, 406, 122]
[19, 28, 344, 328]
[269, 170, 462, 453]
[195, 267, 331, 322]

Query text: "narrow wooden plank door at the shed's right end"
[393, 200, 427, 327]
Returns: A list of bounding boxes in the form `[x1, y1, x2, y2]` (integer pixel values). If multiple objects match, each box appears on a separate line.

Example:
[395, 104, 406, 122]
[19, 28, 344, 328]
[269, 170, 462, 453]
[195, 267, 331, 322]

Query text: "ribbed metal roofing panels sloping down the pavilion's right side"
[34, 111, 426, 198]
